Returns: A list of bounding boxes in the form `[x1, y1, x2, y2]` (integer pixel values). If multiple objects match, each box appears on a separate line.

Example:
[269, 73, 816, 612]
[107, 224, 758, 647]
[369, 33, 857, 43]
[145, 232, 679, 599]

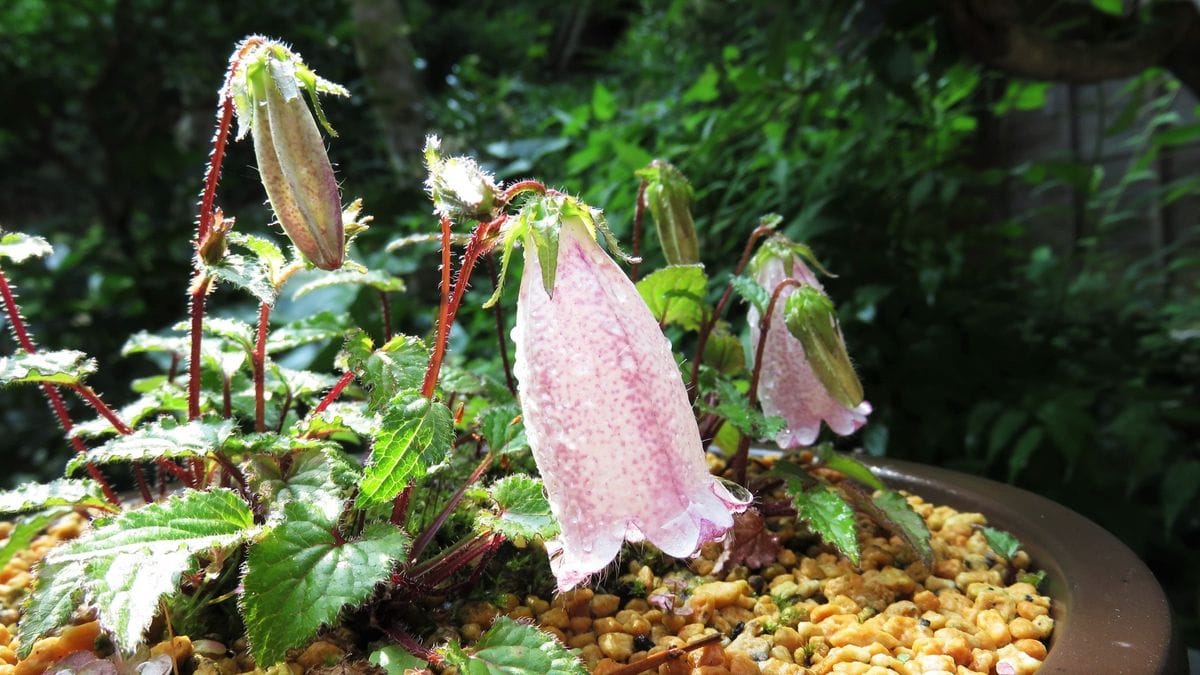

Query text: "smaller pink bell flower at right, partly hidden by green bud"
[748, 238, 871, 449]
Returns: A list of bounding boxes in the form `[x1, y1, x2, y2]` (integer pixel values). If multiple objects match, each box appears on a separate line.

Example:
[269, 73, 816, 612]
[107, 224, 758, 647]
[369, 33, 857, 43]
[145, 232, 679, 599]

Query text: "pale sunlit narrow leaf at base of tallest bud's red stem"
[66, 419, 233, 476]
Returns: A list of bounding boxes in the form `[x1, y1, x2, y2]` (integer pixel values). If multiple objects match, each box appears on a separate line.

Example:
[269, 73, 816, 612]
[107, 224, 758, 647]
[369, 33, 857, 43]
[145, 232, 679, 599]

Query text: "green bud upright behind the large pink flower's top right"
[637, 160, 700, 265]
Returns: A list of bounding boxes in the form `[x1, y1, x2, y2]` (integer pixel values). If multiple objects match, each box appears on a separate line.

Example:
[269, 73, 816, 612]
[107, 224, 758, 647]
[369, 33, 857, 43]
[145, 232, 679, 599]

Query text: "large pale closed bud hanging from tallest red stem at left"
[234, 42, 346, 269]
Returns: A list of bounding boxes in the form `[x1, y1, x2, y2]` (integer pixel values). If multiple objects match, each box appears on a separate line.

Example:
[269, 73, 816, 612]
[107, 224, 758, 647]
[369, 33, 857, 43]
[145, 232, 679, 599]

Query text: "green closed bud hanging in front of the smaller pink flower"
[784, 286, 863, 408]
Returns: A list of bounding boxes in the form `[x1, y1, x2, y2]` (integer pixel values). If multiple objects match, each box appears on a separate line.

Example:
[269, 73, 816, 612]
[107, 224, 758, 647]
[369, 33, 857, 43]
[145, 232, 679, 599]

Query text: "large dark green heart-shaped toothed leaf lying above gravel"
[241, 502, 410, 667]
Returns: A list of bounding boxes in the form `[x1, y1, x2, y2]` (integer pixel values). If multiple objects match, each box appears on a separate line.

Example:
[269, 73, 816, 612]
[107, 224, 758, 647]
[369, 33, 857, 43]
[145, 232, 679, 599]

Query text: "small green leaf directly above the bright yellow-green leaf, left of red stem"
[343, 329, 430, 411]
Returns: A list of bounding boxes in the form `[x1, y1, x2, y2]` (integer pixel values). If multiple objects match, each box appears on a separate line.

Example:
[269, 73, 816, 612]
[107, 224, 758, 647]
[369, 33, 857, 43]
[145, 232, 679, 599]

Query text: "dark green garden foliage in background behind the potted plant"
[0, 0, 1200, 644]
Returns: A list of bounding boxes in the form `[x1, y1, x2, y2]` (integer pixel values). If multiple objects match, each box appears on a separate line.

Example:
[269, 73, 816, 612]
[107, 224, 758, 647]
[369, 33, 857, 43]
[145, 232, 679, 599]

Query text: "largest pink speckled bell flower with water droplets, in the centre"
[512, 196, 746, 590]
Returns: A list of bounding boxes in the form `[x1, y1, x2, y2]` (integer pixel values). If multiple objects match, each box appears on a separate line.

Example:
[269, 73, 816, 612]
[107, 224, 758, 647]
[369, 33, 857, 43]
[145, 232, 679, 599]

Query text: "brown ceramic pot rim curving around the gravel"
[865, 458, 1188, 675]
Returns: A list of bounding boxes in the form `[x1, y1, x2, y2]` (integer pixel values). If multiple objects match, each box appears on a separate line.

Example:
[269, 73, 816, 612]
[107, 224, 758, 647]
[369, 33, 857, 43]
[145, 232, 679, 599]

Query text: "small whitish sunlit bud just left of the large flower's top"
[425, 136, 499, 222]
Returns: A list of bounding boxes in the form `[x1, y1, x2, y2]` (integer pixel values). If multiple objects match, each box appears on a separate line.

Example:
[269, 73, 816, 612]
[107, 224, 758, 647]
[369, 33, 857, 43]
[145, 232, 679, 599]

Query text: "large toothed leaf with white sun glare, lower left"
[46, 489, 254, 652]
